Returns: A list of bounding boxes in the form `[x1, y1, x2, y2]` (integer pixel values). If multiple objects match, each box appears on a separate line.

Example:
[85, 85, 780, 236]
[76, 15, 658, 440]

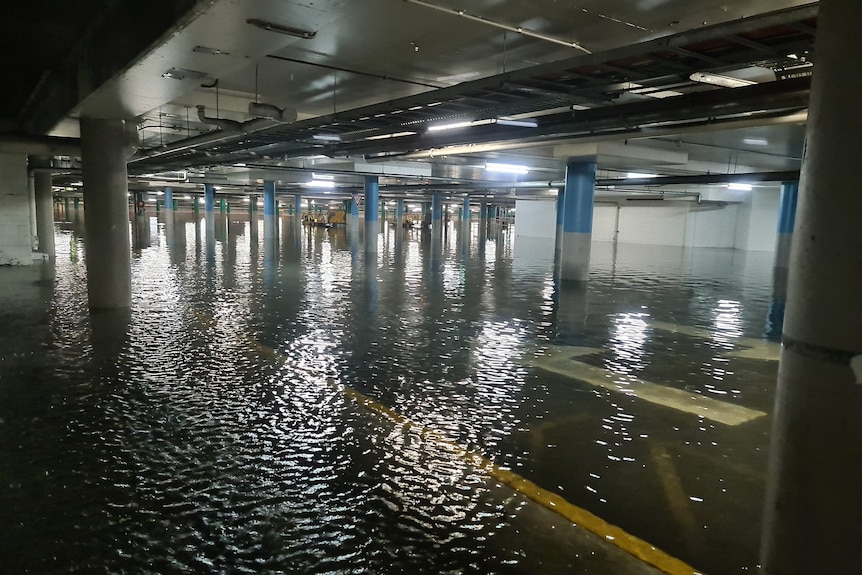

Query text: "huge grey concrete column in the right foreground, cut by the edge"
[761, 0, 862, 575]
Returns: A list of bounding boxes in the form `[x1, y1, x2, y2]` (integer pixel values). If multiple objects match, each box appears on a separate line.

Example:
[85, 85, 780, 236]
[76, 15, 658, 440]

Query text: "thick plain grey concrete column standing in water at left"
[80, 118, 132, 310]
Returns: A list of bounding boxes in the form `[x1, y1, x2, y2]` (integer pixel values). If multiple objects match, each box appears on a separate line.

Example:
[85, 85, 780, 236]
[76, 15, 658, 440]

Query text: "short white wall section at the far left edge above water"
[0, 154, 34, 265]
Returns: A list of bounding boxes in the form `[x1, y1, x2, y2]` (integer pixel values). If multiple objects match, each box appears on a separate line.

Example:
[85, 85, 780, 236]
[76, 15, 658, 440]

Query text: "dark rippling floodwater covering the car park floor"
[0, 213, 781, 573]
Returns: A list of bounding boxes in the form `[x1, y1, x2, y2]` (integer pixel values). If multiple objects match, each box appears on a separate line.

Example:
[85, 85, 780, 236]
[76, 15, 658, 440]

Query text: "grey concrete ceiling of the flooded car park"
[0, 0, 811, 198]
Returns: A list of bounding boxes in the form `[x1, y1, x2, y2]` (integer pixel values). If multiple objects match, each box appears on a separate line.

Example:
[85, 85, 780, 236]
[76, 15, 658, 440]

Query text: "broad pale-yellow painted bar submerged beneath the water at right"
[533, 353, 766, 425]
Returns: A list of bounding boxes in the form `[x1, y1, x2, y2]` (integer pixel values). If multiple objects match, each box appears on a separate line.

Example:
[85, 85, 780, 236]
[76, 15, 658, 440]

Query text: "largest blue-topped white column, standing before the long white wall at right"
[560, 161, 596, 281]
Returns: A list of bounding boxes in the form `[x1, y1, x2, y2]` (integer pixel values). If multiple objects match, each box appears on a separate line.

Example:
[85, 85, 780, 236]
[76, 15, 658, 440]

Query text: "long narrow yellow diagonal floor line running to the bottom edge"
[189, 309, 702, 575]
